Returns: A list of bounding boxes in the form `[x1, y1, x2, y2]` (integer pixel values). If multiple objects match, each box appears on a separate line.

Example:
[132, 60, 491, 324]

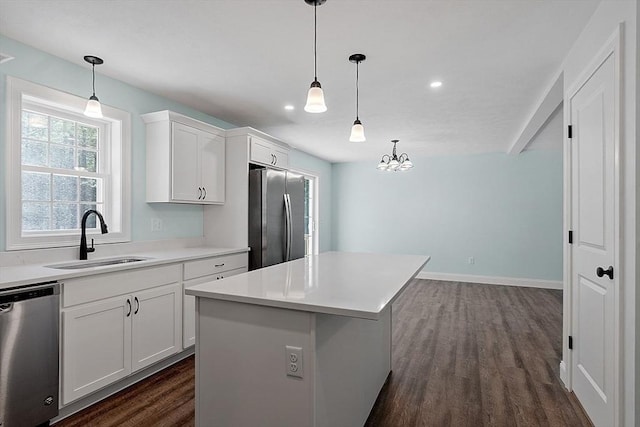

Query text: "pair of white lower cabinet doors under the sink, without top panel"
[62, 283, 182, 405]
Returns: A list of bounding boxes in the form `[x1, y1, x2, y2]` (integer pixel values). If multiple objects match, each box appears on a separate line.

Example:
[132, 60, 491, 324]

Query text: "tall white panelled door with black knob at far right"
[569, 50, 618, 426]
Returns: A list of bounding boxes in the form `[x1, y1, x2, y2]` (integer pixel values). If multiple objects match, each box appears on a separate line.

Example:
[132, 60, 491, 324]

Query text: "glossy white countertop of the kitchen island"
[186, 252, 430, 320]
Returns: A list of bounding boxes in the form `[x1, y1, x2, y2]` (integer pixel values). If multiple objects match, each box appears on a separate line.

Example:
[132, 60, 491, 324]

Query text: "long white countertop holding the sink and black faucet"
[0, 247, 249, 290]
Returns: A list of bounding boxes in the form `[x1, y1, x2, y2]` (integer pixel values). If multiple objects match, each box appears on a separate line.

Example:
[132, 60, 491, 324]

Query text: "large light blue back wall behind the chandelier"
[332, 150, 562, 280]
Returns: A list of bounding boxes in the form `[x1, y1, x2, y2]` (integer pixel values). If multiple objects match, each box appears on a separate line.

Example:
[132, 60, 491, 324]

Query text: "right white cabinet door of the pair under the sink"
[131, 283, 182, 372]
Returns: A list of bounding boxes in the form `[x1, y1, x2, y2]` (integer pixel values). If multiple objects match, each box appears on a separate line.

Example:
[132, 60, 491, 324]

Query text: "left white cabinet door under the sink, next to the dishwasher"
[62, 296, 133, 405]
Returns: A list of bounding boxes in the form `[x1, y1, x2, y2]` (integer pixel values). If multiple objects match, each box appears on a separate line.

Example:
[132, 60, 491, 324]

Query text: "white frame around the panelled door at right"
[560, 23, 624, 426]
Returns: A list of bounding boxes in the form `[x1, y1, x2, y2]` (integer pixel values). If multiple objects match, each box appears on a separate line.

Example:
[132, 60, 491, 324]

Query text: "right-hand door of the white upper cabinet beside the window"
[199, 132, 225, 203]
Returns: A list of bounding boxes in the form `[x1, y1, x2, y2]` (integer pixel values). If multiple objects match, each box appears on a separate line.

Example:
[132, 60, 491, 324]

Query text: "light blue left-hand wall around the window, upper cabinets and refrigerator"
[0, 35, 338, 251]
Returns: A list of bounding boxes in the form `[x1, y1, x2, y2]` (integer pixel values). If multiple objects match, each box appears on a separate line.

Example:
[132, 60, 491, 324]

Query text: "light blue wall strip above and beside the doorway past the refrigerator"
[289, 150, 332, 252]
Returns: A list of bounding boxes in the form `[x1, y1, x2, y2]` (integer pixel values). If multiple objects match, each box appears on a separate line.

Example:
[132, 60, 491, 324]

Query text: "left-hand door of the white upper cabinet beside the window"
[171, 122, 201, 202]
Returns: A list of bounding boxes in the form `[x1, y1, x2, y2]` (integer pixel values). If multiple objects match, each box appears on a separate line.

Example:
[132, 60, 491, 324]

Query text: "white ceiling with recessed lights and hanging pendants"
[0, 0, 599, 162]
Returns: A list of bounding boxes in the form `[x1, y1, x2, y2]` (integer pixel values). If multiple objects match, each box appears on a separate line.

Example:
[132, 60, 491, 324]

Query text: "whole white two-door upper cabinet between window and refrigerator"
[141, 110, 225, 204]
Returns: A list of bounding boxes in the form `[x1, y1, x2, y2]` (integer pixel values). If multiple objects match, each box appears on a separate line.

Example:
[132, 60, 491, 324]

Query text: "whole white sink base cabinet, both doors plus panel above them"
[61, 264, 182, 405]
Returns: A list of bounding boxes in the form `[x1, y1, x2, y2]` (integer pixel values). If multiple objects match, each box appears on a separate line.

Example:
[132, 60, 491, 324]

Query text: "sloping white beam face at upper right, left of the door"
[507, 71, 564, 155]
